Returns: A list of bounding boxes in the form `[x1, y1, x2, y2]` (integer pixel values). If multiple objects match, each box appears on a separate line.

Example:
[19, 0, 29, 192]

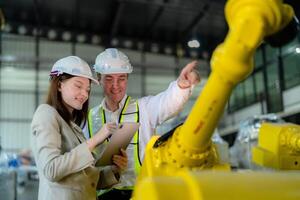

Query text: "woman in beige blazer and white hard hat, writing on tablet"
[31, 56, 127, 200]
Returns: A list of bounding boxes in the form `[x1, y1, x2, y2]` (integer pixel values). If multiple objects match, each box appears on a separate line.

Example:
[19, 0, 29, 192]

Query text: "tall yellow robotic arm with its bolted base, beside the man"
[133, 0, 300, 199]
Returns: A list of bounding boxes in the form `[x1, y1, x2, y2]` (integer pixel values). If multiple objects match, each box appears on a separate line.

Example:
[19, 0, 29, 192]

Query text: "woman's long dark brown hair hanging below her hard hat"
[46, 74, 89, 126]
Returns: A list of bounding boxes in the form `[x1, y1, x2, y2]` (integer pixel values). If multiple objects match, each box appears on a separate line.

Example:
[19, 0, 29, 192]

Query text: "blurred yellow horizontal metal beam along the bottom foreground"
[134, 171, 300, 200]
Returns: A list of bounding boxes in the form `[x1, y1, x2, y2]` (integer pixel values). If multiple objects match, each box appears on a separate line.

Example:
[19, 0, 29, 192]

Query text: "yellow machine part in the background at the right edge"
[252, 123, 300, 170]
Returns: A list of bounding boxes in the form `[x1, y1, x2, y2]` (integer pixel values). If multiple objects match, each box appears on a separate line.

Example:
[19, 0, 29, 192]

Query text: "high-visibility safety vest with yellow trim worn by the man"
[88, 96, 141, 175]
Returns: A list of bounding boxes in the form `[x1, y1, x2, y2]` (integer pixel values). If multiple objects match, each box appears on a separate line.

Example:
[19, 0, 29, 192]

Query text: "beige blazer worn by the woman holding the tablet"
[31, 104, 118, 200]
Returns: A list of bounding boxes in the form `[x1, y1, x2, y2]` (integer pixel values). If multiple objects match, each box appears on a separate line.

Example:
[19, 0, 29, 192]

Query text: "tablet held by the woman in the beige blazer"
[96, 122, 140, 166]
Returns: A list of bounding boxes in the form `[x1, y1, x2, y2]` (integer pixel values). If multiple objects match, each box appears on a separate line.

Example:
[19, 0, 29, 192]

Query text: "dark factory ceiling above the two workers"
[0, 0, 300, 58]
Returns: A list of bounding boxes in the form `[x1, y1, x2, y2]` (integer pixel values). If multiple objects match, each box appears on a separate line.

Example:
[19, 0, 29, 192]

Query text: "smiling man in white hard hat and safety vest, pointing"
[85, 48, 200, 199]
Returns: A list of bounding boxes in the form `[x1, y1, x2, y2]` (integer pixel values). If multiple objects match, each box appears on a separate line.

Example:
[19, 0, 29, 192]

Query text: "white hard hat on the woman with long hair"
[50, 56, 99, 84]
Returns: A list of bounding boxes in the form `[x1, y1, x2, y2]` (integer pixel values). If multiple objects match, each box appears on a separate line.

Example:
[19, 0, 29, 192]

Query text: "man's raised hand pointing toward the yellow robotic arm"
[177, 61, 200, 89]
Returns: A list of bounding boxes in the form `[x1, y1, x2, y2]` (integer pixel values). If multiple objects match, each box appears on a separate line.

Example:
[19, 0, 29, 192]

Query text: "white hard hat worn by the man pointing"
[94, 48, 132, 74]
